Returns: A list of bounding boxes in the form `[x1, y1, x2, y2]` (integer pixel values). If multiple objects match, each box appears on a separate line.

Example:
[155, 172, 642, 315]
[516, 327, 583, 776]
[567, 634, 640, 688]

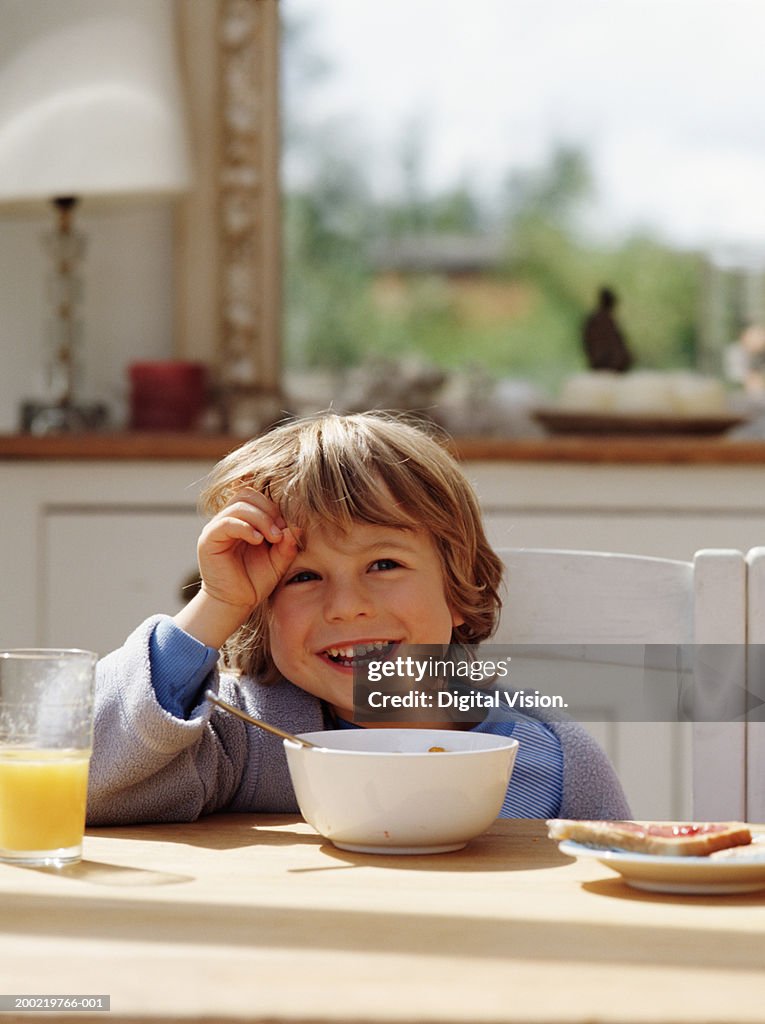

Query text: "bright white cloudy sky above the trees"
[282, 0, 765, 260]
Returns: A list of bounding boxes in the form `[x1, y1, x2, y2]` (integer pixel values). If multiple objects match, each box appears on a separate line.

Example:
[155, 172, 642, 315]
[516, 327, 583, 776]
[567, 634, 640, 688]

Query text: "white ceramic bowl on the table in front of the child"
[285, 729, 518, 854]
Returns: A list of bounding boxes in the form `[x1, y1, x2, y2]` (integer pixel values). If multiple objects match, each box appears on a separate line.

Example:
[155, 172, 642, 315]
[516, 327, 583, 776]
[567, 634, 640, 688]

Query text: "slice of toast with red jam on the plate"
[547, 818, 752, 857]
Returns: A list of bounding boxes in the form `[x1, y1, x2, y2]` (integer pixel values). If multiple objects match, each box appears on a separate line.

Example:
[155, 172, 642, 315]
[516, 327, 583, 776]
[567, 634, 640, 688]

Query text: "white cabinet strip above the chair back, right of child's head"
[466, 462, 765, 561]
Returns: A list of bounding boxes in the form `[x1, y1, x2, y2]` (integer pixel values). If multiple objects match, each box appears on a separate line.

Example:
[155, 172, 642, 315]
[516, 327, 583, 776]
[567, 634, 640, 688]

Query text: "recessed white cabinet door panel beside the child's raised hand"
[42, 507, 202, 654]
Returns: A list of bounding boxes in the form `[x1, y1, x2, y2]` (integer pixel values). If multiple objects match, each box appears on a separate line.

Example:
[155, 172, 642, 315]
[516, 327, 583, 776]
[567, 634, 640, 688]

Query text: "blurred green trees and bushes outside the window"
[284, 109, 700, 391]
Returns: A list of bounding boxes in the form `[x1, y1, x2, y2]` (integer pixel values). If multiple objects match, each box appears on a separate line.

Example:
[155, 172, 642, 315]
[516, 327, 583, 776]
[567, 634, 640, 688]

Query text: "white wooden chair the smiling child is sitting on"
[493, 548, 745, 820]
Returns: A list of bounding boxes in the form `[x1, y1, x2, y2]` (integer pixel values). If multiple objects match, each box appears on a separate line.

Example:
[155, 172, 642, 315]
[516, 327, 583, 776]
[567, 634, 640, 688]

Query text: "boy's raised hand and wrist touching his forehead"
[175, 486, 297, 647]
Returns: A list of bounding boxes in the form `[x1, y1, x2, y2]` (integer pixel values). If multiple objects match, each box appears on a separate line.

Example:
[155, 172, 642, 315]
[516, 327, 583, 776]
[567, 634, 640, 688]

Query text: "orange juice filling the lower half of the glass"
[0, 746, 90, 857]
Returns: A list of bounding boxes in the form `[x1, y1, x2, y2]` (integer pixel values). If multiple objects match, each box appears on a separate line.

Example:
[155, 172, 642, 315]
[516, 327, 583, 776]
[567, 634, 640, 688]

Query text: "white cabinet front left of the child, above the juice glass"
[0, 461, 210, 654]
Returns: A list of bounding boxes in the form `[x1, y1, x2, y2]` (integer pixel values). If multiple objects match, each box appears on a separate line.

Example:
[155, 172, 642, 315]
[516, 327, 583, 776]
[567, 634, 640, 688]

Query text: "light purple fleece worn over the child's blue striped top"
[88, 616, 630, 825]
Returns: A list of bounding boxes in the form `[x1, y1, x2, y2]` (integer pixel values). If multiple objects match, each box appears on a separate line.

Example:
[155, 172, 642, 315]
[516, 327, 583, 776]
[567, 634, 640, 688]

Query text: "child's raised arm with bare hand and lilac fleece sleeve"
[88, 485, 297, 824]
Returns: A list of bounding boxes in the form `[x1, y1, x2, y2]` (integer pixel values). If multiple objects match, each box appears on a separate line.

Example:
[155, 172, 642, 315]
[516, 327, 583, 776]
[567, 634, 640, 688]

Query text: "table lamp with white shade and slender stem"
[0, 0, 189, 433]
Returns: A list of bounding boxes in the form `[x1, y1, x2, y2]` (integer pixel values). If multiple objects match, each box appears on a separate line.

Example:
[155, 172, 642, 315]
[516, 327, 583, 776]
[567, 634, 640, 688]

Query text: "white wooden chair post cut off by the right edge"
[747, 548, 765, 821]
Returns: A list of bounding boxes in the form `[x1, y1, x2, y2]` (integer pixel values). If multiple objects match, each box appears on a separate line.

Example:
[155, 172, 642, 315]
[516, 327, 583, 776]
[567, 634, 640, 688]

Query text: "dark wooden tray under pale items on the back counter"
[533, 409, 745, 436]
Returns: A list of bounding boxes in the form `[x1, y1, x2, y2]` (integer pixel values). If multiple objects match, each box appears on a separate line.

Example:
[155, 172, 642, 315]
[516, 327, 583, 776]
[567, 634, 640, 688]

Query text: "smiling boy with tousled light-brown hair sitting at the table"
[88, 413, 629, 824]
